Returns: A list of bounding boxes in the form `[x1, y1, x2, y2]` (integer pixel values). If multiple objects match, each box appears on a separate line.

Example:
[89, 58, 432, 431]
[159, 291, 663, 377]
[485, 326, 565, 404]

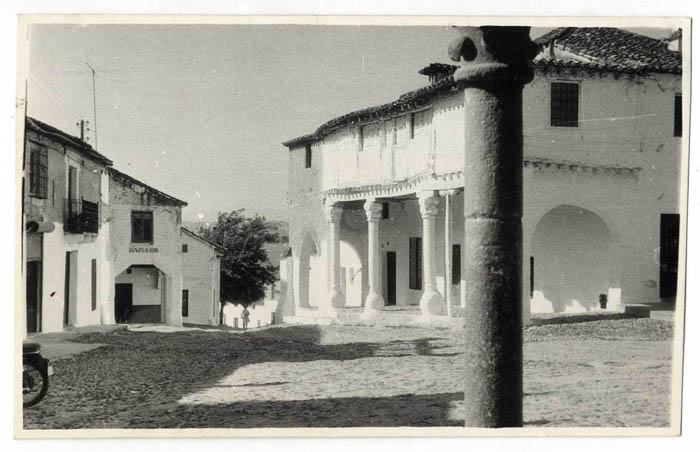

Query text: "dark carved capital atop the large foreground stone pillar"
[448, 26, 537, 85]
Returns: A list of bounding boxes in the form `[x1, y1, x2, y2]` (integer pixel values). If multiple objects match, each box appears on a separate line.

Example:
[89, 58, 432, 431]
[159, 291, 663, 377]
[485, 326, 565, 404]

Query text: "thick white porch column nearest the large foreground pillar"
[418, 190, 445, 317]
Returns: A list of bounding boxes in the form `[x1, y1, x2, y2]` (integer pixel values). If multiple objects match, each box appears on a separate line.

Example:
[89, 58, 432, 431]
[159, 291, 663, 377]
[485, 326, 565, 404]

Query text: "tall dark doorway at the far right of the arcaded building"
[659, 213, 680, 301]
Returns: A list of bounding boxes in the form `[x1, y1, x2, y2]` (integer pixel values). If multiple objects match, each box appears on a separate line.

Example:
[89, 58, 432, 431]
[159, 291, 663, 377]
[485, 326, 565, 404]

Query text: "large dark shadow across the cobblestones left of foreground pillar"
[24, 325, 461, 429]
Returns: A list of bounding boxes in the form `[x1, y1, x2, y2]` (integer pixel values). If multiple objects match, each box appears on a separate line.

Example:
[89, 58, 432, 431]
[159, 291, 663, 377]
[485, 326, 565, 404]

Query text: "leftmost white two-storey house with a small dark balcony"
[22, 118, 112, 333]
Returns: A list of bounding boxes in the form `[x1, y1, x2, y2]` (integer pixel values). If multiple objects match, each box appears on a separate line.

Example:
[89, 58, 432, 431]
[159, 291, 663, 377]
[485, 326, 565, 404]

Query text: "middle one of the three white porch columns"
[365, 198, 384, 317]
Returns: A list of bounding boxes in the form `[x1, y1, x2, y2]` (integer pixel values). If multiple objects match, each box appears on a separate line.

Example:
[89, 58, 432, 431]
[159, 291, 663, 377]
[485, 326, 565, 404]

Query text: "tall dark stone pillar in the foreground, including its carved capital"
[449, 27, 536, 427]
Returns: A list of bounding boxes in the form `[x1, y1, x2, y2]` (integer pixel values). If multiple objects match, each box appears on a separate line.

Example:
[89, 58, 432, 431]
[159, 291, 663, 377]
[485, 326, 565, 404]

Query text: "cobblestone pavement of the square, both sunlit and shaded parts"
[24, 317, 672, 429]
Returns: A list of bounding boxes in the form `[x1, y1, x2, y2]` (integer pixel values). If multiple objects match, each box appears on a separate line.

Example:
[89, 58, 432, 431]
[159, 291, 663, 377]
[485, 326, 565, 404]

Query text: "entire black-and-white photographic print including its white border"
[14, 15, 692, 438]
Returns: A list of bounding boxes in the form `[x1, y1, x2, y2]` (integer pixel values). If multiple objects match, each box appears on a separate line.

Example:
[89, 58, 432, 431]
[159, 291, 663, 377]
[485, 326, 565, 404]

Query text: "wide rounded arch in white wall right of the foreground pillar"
[530, 205, 615, 312]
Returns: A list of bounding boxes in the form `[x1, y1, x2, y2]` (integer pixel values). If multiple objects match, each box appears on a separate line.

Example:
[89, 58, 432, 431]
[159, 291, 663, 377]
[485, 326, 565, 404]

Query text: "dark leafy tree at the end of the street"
[200, 209, 279, 323]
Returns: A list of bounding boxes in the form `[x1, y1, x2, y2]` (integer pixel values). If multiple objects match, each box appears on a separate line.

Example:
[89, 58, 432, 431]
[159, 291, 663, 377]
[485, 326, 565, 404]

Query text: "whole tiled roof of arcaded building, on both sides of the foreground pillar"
[282, 27, 681, 148]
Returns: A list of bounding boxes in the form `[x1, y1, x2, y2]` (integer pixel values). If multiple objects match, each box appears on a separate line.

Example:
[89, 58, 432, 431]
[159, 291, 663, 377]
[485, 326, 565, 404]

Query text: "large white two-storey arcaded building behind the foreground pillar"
[278, 28, 682, 321]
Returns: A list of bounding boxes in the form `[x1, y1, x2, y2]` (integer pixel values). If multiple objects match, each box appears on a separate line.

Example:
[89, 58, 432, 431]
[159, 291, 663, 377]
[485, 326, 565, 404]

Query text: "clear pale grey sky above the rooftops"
[27, 24, 669, 221]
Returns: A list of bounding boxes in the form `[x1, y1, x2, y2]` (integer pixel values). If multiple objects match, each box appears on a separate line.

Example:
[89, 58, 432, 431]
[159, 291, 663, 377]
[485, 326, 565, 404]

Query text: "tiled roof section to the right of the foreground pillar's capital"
[535, 27, 681, 74]
